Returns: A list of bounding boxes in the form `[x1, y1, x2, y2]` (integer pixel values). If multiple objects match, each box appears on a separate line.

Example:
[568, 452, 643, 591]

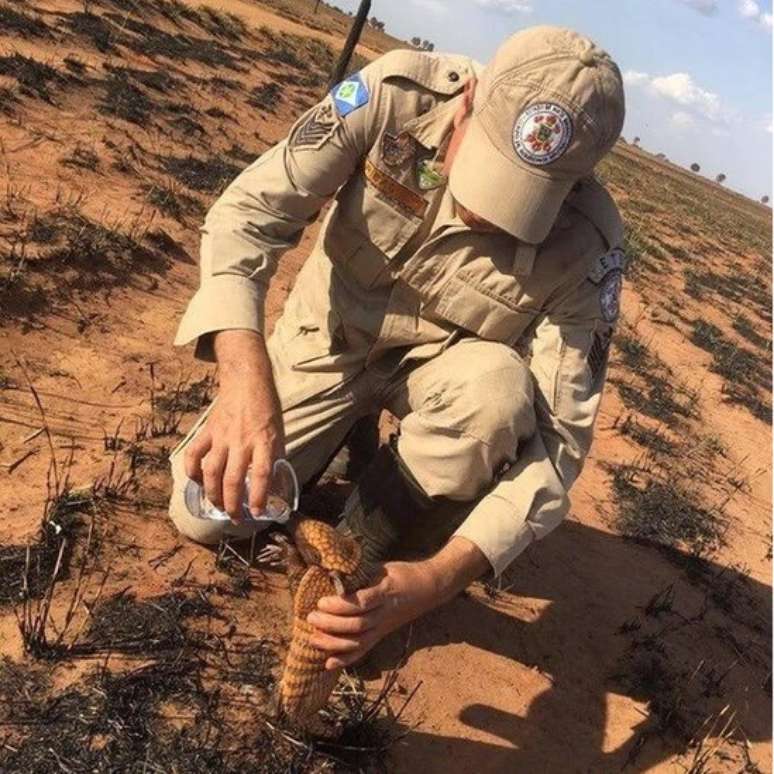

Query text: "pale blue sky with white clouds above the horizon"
[331, 0, 772, 199]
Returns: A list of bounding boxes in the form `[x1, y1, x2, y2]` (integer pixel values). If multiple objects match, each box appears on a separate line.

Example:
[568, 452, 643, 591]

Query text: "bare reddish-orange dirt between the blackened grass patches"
[0, 0, 771, 774]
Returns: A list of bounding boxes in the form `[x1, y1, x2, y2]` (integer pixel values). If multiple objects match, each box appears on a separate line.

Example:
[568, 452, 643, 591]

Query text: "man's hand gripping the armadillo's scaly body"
[307, 562, 443, 669]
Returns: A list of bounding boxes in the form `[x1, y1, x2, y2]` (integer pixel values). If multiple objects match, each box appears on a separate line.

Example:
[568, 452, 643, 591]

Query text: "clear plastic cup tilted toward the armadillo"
[183, 459, 299, 526]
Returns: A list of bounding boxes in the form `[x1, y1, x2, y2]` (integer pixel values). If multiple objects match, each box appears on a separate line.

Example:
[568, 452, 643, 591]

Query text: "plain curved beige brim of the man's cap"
[449, 118, 574, 244]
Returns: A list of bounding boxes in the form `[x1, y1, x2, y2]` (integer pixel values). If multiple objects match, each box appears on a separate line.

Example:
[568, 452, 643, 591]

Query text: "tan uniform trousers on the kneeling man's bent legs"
[169, 334, 536, 544]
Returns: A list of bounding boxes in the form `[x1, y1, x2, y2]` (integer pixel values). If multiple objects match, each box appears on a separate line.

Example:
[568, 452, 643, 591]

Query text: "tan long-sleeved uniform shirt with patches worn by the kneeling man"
[175, 51, 623, 573]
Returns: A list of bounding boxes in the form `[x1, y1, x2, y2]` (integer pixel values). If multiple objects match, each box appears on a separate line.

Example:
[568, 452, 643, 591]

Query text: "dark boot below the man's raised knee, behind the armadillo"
[337, 436, 435, 563]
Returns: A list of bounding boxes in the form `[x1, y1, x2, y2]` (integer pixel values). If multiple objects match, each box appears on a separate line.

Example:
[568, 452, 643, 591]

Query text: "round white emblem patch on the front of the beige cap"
[513, 102, 573, 167]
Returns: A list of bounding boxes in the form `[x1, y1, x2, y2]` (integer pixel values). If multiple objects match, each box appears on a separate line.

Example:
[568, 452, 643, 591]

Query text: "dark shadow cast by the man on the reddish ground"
[365, 522, 771, 774]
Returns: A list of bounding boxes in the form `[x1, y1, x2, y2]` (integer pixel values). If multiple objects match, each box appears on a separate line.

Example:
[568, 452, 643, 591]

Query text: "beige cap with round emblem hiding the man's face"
[449, 27, 624, 244]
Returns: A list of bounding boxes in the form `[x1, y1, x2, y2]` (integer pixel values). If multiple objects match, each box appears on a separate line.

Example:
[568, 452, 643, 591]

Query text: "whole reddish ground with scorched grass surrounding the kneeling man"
[0, 0, 771, 772]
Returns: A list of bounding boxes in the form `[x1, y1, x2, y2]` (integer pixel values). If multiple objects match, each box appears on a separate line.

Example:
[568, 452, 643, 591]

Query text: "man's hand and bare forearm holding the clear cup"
[185, 330, 285, 521]
